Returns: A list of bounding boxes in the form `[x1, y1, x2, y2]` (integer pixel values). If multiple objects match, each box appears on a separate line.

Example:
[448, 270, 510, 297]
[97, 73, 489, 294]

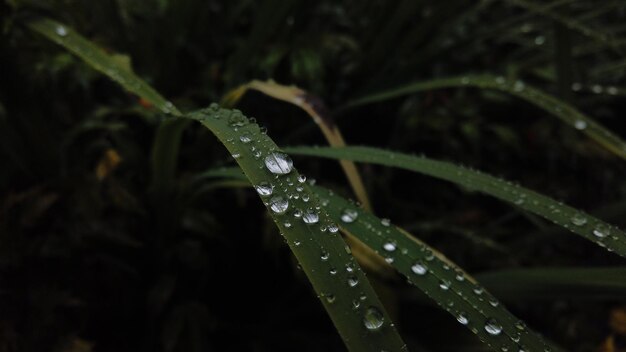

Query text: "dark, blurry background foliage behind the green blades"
[0, 0, 626, 352]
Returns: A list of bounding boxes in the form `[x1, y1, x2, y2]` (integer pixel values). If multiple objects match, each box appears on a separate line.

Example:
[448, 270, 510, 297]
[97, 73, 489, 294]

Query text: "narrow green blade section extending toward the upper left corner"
[26, 18, 181, 116]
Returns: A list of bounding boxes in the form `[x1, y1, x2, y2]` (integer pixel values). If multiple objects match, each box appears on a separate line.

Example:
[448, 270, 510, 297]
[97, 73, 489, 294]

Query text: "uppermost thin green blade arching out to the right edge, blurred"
[340, 75, 626, 159]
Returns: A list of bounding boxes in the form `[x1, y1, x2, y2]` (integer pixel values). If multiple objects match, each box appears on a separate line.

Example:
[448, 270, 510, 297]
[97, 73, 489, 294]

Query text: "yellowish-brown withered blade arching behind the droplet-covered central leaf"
[222, 80, 372, 210]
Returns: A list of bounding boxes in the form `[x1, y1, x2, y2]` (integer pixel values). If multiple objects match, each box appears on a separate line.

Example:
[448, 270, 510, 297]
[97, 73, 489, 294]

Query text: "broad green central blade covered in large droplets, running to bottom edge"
[188, 105, 406, 351]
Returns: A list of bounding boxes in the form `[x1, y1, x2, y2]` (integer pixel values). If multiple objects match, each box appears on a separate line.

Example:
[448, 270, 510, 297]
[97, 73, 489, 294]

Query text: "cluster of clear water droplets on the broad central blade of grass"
[208, 105, 400, 332]
